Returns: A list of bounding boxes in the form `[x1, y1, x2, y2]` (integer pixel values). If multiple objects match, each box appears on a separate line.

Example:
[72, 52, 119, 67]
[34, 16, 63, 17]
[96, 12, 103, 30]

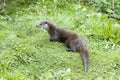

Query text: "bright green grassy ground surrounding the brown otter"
[0, 1, 120, 80]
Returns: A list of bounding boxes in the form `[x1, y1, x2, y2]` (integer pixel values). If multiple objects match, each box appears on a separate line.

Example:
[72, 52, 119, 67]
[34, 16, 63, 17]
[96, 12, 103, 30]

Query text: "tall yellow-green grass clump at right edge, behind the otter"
[86, 13, 120, 44]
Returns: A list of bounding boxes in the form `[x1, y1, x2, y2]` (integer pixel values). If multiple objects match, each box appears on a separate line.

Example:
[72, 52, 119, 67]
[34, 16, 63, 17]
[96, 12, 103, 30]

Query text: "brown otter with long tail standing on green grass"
[36, 20, 89, 72]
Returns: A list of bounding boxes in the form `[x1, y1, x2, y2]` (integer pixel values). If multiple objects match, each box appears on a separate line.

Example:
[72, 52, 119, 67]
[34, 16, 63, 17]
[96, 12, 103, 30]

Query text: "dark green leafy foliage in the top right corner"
[90, 0, 120, 20]
